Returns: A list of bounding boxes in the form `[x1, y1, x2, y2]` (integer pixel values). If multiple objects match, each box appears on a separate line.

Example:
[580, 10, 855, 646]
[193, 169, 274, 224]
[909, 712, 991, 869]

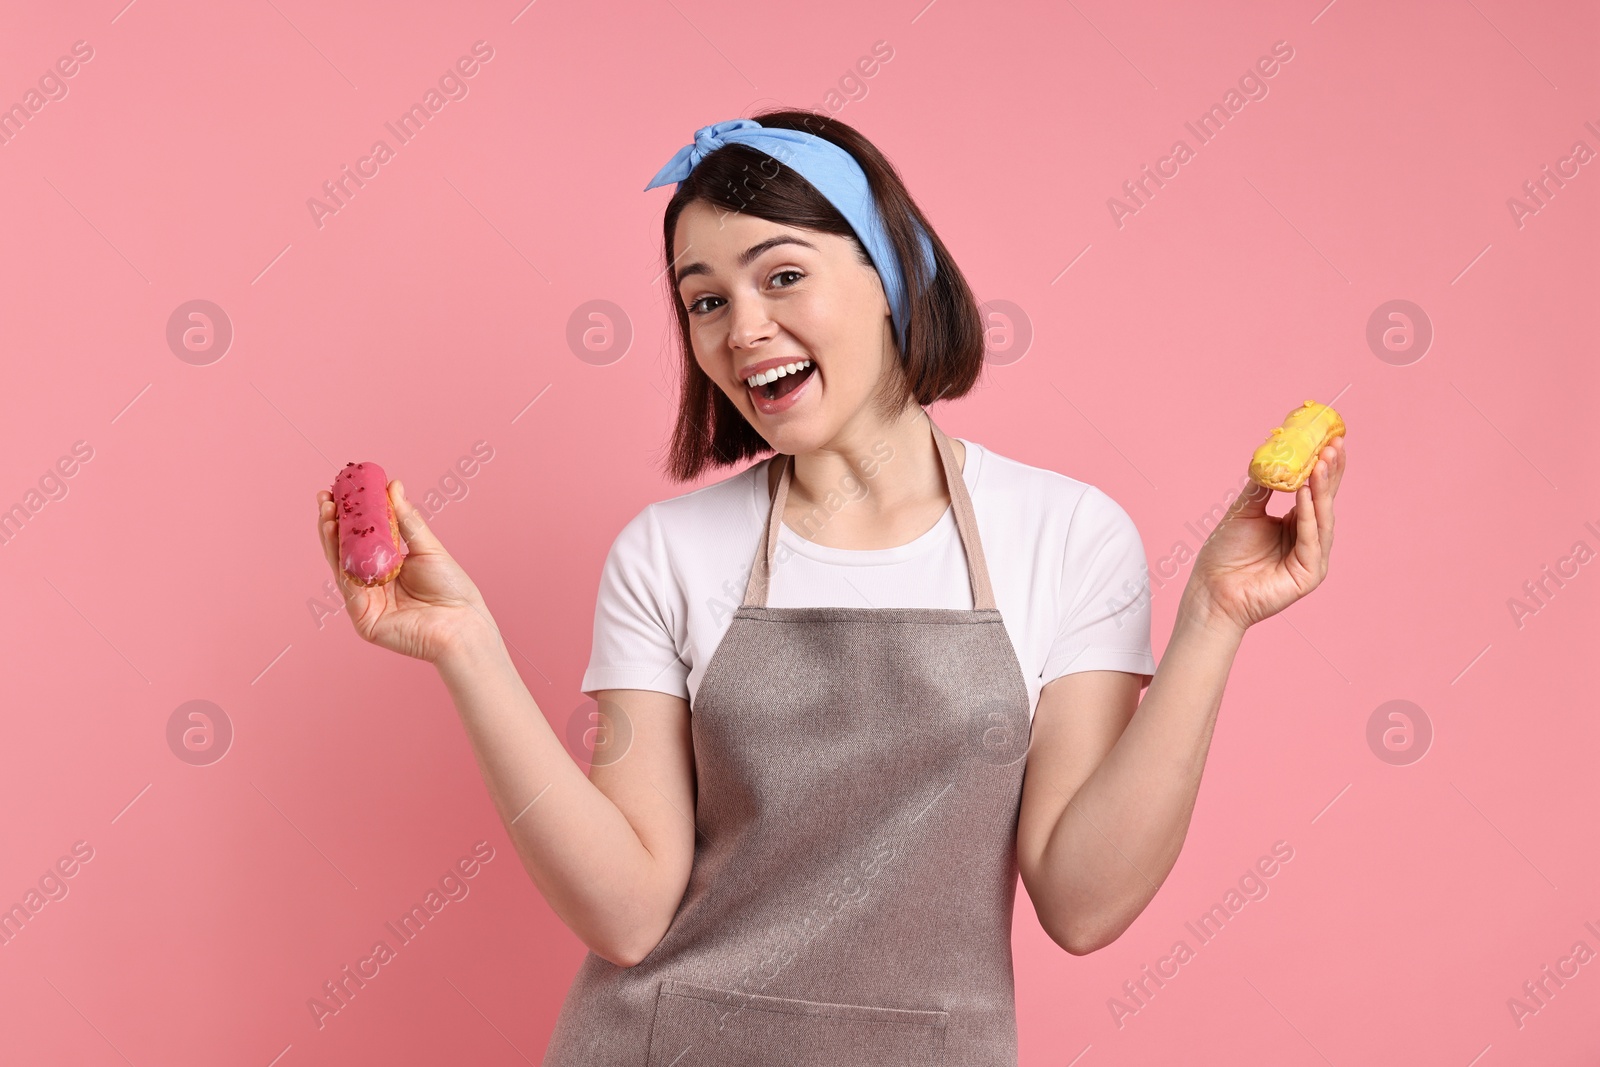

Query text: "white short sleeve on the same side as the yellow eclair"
[1040, 486, 1155, 688]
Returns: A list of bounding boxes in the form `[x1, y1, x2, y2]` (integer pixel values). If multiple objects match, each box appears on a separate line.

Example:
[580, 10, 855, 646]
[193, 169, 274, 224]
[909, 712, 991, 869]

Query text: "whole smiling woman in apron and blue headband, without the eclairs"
[320, 112, 1344, 1067]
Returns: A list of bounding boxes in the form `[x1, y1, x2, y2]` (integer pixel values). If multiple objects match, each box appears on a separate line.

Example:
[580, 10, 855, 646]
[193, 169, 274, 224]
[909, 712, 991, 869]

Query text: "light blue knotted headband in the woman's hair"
[645, 118, 934, 346]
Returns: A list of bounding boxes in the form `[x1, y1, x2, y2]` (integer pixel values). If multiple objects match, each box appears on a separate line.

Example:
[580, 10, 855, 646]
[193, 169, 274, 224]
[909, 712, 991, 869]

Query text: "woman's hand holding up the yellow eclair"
[1184, 434, 1344, 632]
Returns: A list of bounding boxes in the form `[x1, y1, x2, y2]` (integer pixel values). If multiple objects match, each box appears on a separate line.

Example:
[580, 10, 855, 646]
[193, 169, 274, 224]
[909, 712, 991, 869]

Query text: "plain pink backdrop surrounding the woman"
[0, 0, 1600, 1067]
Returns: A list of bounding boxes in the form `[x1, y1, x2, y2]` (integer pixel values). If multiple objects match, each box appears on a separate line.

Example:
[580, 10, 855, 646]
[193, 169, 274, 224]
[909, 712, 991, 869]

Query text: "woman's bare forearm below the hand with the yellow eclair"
[1042, 590, 1243, 952]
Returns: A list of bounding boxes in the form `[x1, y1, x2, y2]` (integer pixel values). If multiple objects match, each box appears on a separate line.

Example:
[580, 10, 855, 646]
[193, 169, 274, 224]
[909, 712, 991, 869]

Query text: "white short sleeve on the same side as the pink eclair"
[581, 506, 690, 699]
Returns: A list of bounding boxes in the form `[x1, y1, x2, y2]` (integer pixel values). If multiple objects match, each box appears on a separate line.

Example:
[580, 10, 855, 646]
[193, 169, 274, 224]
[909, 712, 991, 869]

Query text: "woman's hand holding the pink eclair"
[317, 478, 498, 662]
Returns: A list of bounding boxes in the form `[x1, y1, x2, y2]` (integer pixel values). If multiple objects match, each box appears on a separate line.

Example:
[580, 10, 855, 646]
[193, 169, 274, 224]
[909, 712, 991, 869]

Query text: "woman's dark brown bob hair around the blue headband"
[661, 110, 984, 482]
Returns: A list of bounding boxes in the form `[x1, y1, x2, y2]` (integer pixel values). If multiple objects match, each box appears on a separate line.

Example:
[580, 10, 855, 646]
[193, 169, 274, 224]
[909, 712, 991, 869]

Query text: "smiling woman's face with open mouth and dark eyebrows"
[674, 200, 898, 454]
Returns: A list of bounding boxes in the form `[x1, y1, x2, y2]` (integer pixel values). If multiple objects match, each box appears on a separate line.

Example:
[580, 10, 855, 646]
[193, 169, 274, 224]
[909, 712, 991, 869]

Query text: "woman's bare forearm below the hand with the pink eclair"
[435, 627, 677, 965]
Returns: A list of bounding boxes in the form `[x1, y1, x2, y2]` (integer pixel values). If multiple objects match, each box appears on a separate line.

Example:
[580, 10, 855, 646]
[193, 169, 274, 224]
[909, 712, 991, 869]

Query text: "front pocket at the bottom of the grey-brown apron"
[648, 979, 947, 1067]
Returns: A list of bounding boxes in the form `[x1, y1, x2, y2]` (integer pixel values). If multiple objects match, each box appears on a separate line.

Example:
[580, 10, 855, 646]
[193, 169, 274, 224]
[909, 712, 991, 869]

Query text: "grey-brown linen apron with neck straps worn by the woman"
[542, 419, 1030, 1067]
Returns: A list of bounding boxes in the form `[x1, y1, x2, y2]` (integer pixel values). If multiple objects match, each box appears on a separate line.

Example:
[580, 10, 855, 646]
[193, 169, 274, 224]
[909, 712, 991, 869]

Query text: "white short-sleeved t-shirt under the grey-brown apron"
[582, 438, 1155, 715]
